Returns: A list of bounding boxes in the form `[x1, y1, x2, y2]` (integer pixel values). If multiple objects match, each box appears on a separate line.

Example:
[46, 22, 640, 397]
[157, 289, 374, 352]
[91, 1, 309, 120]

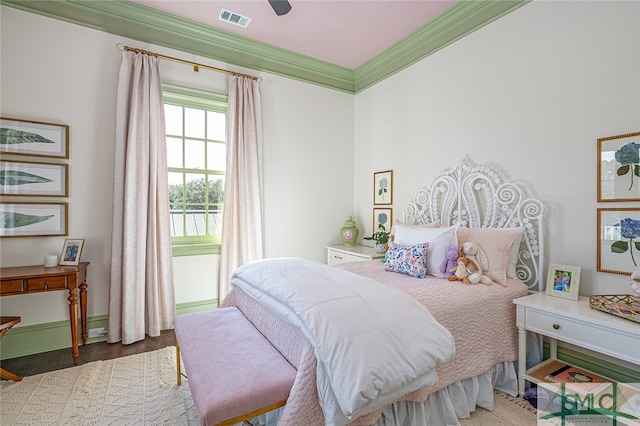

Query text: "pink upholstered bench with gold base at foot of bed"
[174, 307, 296, 425]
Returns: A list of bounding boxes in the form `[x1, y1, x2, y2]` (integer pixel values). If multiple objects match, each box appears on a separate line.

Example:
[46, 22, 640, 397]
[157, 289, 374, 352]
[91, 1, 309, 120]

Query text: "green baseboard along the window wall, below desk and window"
[0, 299, 219, 360]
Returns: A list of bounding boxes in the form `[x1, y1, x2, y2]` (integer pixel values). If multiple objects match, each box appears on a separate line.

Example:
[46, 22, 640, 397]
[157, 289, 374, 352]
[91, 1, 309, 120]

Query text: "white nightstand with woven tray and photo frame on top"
[513, 293, 640, 396]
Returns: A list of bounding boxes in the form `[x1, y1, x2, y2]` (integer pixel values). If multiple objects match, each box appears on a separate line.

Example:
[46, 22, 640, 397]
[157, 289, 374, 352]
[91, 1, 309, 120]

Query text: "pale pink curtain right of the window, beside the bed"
[219, 76, 263, 300]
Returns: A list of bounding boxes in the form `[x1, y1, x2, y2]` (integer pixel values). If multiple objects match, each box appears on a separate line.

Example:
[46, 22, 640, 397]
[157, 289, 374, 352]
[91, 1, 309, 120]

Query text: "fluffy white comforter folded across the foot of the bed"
[231, 259, 455, 425]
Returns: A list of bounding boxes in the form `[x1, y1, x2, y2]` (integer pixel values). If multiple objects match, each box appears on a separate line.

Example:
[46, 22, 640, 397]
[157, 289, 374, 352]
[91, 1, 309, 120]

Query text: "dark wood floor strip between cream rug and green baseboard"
[0, 330, 175, 380]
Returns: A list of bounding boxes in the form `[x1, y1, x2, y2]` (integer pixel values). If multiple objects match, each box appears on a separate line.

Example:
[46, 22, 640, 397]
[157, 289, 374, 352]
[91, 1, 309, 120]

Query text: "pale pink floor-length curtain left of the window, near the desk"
[107, 51, 175, 344]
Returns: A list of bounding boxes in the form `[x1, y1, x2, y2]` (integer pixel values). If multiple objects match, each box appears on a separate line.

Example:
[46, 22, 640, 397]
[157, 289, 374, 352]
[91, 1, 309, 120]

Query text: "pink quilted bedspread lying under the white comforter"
[221, 261, 528, 425]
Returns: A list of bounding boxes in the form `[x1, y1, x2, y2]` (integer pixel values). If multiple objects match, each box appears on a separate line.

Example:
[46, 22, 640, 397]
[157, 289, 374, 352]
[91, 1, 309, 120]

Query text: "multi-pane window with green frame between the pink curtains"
[163, 85, 227, 256]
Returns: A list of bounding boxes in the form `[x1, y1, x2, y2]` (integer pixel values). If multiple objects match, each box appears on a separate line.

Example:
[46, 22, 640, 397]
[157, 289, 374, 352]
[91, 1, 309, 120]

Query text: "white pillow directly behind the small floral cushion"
[394, 223, 457, 278]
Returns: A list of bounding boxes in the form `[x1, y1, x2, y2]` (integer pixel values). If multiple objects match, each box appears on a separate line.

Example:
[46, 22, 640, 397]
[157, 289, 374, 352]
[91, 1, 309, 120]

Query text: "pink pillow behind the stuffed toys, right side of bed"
[456, 227, 523, 285]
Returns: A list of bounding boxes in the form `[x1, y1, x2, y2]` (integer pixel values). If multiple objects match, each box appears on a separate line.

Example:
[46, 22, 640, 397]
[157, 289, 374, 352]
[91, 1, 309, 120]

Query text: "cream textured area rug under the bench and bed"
[0, 346, 536, 426]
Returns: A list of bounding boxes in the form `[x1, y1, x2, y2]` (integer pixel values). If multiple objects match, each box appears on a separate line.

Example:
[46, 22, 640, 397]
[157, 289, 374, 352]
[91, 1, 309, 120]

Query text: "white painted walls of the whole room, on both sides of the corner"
[0, 1, 640, 325]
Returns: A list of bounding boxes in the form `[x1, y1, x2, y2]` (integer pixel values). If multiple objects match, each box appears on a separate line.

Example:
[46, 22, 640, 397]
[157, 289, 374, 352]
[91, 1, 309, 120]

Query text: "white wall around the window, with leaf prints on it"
[0, 6, 353, 326]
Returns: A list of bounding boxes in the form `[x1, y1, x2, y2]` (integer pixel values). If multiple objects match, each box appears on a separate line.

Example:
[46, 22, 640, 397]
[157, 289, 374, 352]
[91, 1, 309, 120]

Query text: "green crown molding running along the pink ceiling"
[0, 0, 531, 94]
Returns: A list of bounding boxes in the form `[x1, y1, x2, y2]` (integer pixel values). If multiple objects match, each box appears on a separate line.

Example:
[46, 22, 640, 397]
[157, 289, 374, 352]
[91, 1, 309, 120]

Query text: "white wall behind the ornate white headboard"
[354, 1, 640, 295]
